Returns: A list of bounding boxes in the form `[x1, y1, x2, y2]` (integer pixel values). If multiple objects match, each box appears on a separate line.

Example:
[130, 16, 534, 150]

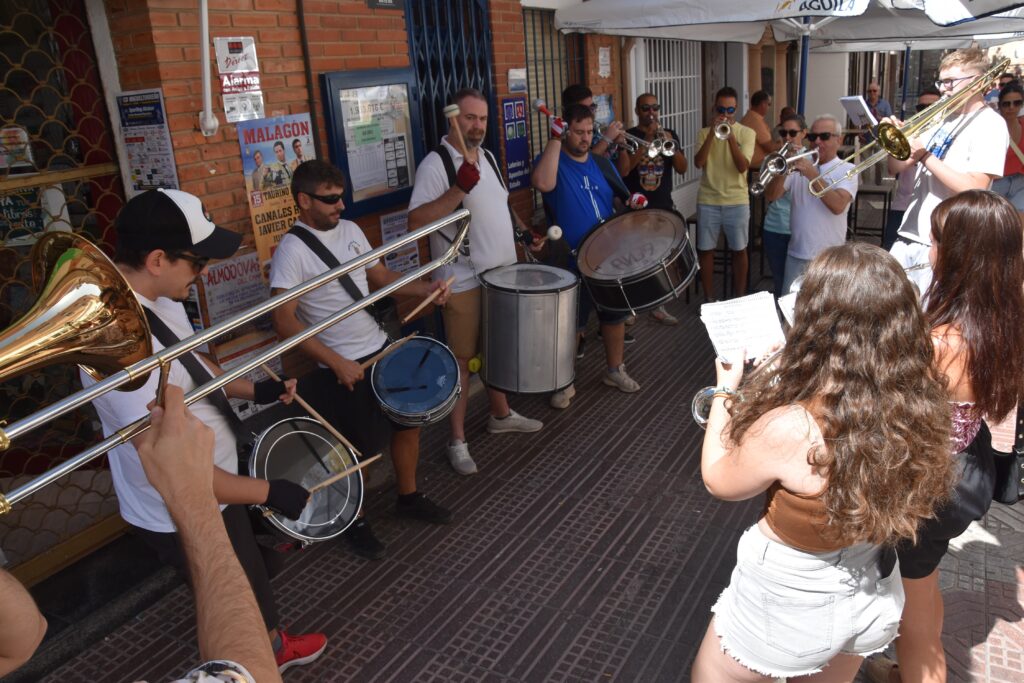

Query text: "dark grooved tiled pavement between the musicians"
[32, 274, 1024, 683]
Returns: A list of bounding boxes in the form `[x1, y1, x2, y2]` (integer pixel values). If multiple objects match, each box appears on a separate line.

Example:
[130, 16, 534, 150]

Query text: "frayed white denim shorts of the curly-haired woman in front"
[712, 524, 903, 678]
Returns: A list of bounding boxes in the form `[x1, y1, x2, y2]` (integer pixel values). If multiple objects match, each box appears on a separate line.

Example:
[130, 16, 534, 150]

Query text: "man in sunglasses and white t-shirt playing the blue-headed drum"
[270, 160, 452, 559]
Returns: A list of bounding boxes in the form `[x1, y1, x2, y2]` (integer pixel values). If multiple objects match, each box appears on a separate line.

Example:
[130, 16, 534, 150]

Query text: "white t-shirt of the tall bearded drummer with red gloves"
[409, 136, 516, 292]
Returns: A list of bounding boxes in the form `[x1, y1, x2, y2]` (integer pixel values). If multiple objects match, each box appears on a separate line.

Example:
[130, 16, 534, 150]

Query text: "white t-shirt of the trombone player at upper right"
[899, 106, 1010, 245]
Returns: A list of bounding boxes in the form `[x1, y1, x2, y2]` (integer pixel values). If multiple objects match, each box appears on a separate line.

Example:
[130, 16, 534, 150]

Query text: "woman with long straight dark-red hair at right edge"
[869, 189, 1024, 683]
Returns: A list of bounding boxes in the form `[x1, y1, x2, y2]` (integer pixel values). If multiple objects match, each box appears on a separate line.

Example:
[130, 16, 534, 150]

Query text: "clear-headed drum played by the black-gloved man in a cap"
[249, 418, 362, 544]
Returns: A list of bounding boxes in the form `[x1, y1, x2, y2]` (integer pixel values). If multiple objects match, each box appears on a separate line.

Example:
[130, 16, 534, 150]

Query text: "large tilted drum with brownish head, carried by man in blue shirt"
[577, 209, 697, 313]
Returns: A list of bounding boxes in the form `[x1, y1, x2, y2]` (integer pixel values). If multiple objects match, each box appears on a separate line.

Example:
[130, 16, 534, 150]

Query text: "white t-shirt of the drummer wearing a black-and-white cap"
[79, 293, 239, 532]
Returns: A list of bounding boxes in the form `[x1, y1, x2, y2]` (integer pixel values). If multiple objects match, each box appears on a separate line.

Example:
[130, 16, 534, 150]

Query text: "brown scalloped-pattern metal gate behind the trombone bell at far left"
[0, 0, 124, 583]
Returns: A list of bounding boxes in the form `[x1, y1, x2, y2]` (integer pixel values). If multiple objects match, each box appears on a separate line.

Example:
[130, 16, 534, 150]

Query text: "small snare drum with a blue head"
[370, 337, 461, 427]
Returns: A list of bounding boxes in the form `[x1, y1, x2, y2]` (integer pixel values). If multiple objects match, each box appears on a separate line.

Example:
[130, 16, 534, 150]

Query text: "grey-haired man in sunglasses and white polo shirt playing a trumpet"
[765, 114, 857, 293]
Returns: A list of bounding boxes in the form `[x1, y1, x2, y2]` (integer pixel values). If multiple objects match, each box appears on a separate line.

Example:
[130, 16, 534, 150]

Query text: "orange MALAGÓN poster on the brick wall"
[238, 114, 316, 278]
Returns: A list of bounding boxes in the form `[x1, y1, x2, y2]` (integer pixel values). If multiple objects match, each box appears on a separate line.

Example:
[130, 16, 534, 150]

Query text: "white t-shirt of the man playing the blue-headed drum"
[270, 220, 387, 360]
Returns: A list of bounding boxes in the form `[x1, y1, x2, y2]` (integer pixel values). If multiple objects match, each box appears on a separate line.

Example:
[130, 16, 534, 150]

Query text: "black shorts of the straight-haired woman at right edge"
[896, 424, 995, 579]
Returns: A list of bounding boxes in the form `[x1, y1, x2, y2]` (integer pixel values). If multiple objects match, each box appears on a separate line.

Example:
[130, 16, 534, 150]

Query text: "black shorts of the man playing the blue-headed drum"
[299, 345, 418, 458]
